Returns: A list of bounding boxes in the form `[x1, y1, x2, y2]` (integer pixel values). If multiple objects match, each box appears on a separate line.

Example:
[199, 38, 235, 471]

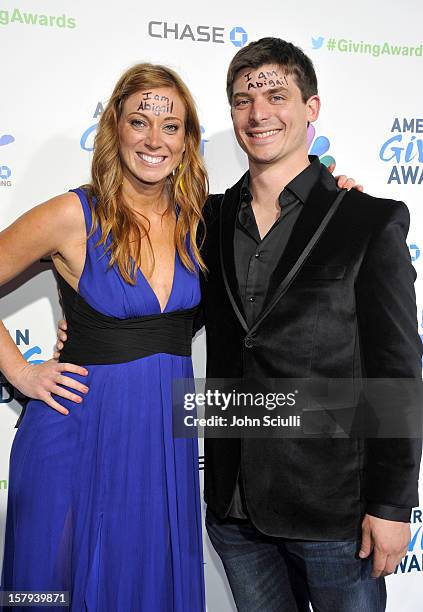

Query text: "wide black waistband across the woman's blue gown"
[57, 274, 199, 365]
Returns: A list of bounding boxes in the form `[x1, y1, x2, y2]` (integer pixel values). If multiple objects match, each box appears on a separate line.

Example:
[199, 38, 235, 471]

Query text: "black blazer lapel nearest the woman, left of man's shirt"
[219, 175, 248, 331]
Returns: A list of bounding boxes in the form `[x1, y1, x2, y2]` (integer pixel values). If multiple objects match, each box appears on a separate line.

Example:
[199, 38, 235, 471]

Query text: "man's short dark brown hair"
[226, 36, 317, 104]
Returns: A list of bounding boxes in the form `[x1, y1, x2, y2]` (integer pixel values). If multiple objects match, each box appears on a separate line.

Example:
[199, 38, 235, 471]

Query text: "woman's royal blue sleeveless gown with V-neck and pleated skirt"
[1, 189, 205, 612]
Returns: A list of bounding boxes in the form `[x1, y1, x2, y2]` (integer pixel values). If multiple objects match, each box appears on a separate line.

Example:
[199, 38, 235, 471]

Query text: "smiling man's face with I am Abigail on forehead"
[231, 64, 320, 164]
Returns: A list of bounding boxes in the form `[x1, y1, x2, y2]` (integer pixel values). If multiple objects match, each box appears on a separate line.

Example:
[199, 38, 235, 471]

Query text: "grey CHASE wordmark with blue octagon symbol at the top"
[148, 21, 248, 47]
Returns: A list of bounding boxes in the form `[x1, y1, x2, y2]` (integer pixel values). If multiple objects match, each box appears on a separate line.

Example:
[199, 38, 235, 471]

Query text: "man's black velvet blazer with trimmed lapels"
[201, 166, 422, 540]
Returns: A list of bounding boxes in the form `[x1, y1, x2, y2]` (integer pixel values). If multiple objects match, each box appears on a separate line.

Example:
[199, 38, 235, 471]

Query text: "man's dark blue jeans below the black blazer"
[206, 510, 386, 612]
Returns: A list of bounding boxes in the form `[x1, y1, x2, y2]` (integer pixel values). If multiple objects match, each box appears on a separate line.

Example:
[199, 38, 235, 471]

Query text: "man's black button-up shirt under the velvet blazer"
[229, 156, 320, 519]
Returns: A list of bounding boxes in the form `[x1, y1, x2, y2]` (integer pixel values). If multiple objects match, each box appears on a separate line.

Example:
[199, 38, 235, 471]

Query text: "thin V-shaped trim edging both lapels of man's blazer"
[219, 189, 347, 335]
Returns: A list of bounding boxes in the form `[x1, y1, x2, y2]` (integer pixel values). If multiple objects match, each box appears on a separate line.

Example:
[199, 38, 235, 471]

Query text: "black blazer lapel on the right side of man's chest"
[264, 166, 338, 308]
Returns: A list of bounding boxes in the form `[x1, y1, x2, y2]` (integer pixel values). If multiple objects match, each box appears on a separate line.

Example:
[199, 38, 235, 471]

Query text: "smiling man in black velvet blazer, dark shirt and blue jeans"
[202, 38, 421, 612]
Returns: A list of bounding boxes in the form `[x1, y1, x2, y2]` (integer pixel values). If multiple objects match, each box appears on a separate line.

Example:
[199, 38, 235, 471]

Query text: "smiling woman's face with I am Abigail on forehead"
[118, 87, 185, 184]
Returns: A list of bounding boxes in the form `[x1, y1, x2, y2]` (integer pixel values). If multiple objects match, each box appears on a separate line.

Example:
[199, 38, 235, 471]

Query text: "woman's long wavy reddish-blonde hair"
[84, 63, 208, 285]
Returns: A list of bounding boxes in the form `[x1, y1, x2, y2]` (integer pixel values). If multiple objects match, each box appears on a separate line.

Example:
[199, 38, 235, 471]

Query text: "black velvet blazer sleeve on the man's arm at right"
[356, 201, 422, 522]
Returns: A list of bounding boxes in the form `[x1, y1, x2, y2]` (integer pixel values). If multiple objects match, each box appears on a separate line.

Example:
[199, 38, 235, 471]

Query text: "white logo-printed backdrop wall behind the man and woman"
[0, 0, 423, 612]
